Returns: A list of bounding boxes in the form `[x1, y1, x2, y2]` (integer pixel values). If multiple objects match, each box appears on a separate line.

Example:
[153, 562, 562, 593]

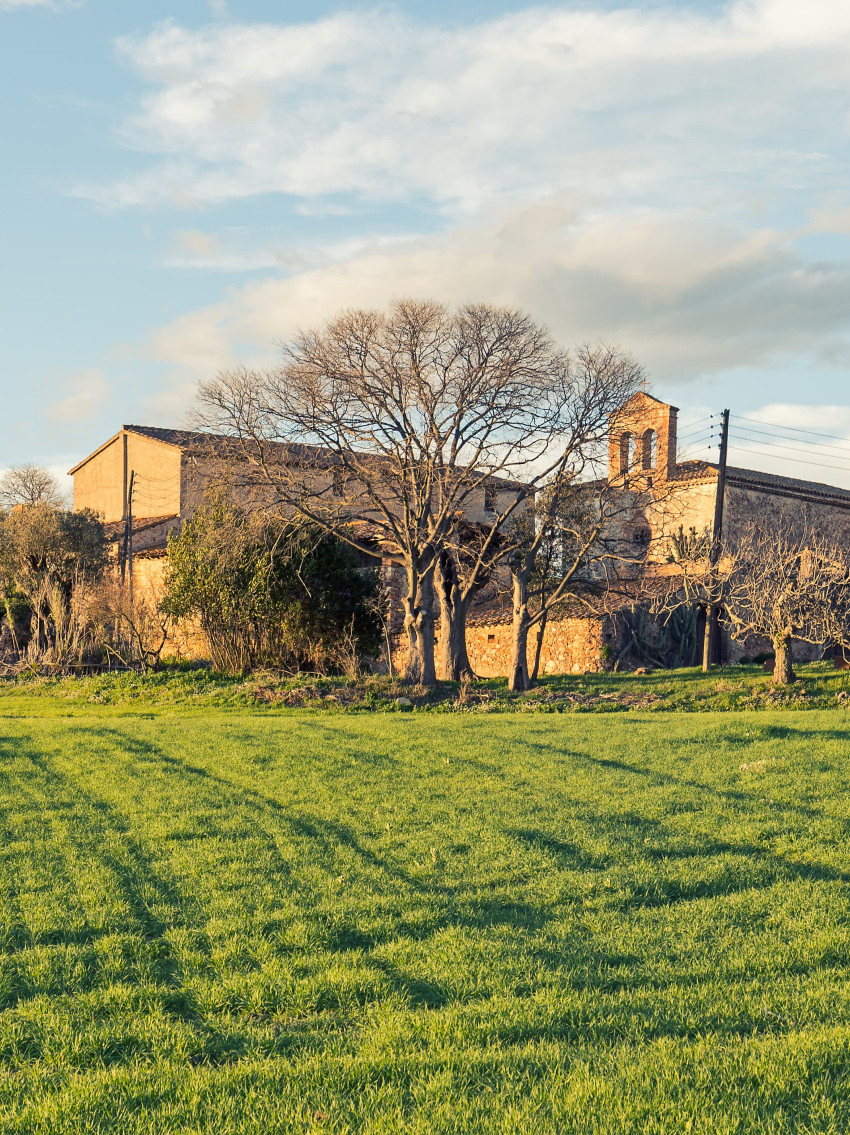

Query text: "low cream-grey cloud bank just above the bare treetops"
[147, 199, 850, 400]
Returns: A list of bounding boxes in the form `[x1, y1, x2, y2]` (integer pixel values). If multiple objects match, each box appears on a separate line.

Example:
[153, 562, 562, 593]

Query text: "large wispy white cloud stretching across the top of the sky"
[81, 0, 850, 215]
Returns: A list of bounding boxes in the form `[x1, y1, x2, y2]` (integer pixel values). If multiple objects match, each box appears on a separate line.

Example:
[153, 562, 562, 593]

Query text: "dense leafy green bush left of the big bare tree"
[163, 488, 379, 672]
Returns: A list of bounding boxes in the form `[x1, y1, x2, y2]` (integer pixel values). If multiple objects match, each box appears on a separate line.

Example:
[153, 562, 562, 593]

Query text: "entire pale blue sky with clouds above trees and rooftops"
[0, 0, 850, 486]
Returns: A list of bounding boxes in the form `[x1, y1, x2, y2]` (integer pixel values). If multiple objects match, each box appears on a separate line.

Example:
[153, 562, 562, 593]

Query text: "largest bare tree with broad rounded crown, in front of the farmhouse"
[201, 301, 567, 686]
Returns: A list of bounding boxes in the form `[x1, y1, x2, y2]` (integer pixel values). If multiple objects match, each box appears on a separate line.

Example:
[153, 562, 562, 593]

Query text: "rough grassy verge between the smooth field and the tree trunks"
[0, 663, 850, 716]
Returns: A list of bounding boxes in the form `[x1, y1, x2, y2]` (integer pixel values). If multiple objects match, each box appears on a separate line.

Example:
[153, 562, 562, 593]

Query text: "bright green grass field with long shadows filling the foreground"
[0, 691, 850, 1135]
